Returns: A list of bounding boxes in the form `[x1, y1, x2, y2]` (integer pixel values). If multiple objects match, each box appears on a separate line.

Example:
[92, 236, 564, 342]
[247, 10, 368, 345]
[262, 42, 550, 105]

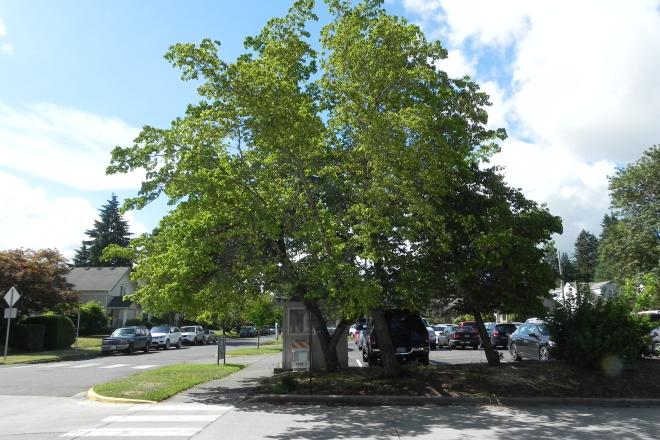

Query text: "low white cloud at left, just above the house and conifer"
[0, 171, 146, 258]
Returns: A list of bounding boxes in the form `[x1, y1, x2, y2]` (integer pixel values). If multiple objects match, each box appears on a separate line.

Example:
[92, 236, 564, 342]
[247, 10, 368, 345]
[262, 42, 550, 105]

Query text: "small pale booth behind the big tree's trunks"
[282, 301, 348, 371]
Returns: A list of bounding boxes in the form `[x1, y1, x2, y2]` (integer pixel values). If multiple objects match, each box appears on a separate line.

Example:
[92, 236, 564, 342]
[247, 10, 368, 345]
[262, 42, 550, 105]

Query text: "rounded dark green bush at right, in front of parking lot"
[550, 294, 652, 368]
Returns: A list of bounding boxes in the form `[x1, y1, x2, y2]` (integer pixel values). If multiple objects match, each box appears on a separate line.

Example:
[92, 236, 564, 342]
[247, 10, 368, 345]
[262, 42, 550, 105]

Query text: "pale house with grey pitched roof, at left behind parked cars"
[66, 267, 142, 327]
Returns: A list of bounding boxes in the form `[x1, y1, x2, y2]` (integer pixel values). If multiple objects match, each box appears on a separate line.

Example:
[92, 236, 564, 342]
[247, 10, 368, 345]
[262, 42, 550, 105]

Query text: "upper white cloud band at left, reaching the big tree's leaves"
[0, 103, 143, 190]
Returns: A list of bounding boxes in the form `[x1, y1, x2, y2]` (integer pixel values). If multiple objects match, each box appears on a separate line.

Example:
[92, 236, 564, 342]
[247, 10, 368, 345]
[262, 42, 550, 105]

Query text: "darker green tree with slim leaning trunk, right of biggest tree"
[425, 168, 562, 365]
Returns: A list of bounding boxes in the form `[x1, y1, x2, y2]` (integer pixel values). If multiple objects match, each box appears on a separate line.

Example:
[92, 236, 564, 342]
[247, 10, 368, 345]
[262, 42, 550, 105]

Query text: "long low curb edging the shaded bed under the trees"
[244, 394, 660, 408]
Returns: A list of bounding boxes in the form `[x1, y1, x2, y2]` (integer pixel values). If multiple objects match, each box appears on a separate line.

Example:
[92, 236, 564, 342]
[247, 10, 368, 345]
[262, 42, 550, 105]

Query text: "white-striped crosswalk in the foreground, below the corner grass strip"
[60, 404, 234, 438]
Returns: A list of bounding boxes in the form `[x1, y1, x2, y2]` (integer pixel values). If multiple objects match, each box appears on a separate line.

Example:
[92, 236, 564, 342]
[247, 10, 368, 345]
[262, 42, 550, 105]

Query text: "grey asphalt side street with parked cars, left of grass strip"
[0, 336, 274, 397]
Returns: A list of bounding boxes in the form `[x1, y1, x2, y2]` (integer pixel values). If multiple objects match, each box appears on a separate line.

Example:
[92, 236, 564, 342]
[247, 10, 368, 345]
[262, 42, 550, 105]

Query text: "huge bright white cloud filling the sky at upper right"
[402, 0, 660, 249]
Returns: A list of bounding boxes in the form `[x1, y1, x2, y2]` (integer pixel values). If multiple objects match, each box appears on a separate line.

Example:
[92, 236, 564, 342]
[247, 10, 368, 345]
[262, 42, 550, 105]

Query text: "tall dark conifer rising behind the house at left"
[74, 194, 131, 267]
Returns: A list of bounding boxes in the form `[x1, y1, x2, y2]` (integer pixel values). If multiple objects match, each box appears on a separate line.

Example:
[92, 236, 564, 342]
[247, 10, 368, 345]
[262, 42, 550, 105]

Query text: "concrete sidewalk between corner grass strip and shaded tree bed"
[165, 353, 282, 405]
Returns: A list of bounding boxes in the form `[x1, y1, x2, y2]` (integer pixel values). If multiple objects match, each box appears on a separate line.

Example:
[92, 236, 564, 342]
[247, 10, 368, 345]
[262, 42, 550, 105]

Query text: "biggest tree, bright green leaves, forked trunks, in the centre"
[108, 0, 504, 374]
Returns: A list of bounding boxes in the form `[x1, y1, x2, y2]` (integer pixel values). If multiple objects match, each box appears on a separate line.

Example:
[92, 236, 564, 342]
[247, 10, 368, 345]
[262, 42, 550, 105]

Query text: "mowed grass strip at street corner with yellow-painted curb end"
[94, 364, 244, 402]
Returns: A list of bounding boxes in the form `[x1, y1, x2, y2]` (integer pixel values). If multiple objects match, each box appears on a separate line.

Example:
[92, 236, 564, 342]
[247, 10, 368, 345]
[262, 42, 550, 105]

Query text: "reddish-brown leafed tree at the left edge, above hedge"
[0, 249, 77, 315]
